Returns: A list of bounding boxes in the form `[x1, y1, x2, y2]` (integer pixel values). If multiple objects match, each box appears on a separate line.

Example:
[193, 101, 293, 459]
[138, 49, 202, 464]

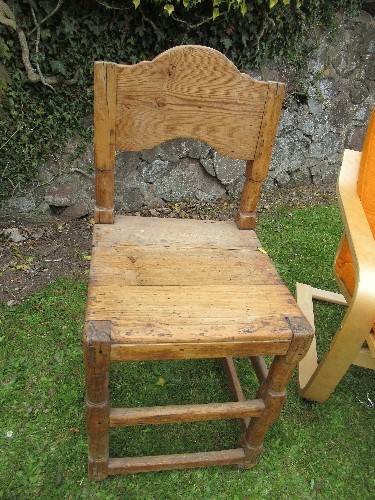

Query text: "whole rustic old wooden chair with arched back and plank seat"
[84, 46, 313, 480]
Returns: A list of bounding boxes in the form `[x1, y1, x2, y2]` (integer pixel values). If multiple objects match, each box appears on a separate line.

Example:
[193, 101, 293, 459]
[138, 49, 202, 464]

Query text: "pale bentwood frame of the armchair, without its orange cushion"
[297, 146, 375, 402]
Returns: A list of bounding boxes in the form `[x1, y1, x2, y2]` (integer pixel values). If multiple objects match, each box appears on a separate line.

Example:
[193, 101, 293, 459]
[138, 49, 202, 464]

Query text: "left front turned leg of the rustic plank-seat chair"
[84, 321, 111, 481]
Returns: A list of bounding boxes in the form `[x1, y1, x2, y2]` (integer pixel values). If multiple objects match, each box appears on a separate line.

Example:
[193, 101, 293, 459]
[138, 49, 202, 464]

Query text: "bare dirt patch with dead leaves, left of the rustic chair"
[0, 219, 92, 306]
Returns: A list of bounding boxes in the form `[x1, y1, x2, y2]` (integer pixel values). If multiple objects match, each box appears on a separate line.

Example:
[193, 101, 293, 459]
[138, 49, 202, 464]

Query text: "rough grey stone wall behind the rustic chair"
[0, 13, 375, 218]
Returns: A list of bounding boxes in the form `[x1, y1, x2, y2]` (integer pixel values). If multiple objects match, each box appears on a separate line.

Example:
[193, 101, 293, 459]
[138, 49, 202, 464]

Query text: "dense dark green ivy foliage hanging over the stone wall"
[0, 0, 360, 198]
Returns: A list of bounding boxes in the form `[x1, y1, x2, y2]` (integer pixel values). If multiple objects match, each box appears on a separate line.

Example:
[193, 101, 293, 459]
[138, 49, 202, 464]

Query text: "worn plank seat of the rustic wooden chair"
[87, 217, 300, 344]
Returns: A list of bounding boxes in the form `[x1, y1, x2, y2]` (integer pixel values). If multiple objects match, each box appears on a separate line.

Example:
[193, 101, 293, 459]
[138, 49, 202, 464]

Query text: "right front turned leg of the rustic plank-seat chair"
[240, 318, 313, 468]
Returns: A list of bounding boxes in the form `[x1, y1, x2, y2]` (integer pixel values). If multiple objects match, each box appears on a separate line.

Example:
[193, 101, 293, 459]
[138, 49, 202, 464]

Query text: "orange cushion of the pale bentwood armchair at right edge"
[335, 108, 375, 294]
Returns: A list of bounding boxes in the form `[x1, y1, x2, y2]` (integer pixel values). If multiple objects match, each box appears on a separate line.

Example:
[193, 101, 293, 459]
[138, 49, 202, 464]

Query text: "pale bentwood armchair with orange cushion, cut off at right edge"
[297, 109, 375, 401]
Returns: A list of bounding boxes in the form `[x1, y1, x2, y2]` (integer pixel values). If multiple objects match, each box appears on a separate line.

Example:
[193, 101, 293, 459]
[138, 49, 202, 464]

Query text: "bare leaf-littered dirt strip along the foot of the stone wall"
[0, 186, 335, 306]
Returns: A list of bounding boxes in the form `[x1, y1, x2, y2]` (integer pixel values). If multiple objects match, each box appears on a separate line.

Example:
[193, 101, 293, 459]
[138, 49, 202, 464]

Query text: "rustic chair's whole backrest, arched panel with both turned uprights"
[94, 45, 285, 228]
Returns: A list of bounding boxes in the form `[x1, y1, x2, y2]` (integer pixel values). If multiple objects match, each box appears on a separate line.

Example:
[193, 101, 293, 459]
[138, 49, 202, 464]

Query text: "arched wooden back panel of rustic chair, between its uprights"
[116, 46, 278, 159]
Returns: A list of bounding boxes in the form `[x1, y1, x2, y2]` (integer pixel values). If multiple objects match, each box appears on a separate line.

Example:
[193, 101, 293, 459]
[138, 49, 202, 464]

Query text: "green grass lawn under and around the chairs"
[0, 206, 375, 500]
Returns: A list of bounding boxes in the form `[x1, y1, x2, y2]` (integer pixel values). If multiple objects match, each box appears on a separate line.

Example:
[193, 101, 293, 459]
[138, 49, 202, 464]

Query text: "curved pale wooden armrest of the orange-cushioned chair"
[337, 149, 375, 308]
